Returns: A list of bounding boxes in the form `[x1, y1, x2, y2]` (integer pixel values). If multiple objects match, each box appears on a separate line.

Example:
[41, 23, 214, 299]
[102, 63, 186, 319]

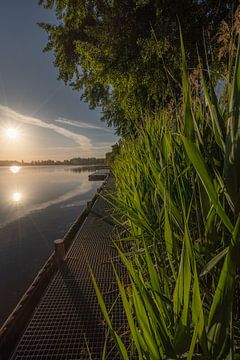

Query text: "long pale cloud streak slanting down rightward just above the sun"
[0, 105, 94, 152]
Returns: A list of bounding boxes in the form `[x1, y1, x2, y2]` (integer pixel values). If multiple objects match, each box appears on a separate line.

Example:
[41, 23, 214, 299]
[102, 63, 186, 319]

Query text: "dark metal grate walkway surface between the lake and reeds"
[11, 179, 126, 360]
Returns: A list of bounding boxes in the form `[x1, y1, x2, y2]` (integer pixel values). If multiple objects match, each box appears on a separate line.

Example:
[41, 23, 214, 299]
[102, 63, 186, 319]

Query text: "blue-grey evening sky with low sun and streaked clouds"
[0, 0, 118, 161]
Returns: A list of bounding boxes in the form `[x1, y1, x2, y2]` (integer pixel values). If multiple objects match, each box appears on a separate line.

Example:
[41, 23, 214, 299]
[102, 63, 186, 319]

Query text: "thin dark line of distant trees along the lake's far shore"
[0, 157, 105, 166]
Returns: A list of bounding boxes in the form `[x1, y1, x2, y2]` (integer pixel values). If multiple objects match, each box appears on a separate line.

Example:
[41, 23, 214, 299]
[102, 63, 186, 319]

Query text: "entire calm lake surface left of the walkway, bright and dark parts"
[0, 166, 100, 325]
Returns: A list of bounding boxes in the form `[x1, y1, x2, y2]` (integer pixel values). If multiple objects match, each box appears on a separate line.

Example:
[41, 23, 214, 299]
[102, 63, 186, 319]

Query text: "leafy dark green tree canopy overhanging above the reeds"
[39, 0, 238, 133]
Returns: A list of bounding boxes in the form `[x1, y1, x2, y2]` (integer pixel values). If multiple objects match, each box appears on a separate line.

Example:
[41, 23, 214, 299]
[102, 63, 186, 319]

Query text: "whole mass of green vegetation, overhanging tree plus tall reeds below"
[40, 0, 240, 360]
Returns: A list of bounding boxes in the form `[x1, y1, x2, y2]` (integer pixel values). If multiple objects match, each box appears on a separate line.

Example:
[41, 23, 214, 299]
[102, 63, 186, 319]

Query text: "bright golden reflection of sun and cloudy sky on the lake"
[0, 164, 99, 228]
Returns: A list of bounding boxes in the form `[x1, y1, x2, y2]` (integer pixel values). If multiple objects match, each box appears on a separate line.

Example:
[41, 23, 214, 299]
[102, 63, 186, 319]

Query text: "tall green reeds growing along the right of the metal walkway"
[92, 35, 240, 360]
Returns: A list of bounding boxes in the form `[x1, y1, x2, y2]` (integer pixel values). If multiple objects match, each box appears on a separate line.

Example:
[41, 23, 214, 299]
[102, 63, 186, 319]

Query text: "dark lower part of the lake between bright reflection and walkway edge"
[0, 190, 95, 326]
